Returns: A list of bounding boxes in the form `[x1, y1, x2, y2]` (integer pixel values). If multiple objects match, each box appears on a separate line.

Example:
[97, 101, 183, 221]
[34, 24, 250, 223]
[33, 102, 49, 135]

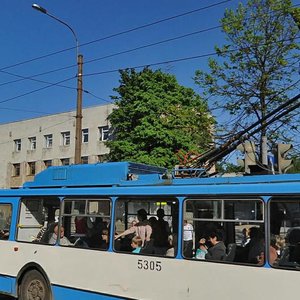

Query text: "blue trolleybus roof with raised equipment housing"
[24, 162, 300, 188]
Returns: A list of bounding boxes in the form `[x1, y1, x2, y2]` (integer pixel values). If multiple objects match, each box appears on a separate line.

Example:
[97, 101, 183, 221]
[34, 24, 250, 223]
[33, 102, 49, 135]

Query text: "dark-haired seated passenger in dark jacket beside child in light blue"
[200, 231, 226, 260]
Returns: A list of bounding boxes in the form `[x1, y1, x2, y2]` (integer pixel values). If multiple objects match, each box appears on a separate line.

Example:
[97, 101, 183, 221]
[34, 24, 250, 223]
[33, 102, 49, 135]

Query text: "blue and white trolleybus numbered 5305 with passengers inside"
[0, 162, 300, 300]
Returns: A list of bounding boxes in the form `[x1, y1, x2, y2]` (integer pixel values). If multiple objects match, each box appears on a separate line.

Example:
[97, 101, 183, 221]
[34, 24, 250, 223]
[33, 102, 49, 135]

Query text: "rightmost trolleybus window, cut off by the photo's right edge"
[269, 196, 300, 270]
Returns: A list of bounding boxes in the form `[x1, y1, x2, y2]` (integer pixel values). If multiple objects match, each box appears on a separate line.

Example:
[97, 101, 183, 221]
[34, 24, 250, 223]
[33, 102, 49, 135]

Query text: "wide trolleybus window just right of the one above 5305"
[182, 198, 265, 265]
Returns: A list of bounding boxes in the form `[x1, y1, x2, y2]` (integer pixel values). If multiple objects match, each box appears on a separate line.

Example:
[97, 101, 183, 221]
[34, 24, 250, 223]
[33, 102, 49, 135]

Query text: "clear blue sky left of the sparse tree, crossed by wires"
[0, 0, 246, 123]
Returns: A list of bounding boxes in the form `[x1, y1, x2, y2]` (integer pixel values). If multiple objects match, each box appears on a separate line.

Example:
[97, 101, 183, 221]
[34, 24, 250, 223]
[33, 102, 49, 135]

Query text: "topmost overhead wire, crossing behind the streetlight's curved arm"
[0, 0, 232, 71]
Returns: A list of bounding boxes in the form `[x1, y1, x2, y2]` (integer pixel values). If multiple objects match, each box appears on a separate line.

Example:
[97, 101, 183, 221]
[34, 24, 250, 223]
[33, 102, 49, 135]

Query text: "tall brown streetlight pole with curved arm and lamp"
[32, 4, 83, 164]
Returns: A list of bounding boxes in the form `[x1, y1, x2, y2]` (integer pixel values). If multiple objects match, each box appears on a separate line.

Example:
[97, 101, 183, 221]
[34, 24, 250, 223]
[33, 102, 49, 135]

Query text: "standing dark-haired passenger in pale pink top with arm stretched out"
[115, 208, 152, 246]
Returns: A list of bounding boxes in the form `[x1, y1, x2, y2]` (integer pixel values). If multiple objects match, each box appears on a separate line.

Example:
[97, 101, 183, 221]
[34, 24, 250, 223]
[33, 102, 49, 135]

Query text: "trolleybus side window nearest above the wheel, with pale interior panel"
[17, 197, 60, 244]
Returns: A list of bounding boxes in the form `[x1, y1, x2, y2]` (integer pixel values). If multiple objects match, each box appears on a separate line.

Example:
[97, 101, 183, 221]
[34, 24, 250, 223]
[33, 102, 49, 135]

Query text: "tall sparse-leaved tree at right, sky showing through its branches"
[195, 0, 299, 161]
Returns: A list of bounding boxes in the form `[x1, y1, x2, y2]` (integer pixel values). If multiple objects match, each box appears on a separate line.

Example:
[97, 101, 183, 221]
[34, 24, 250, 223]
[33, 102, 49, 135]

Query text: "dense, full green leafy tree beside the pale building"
[107, 68, 214, 168]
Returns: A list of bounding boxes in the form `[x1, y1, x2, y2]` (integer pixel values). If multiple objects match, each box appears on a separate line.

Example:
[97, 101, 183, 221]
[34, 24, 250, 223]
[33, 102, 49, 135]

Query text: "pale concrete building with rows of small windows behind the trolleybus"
[0, 104, 114, 188]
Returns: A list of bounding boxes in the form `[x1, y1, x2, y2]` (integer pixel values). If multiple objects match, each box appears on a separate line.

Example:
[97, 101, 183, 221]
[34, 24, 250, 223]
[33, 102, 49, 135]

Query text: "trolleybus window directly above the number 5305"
[114, 196, 178, 257]
